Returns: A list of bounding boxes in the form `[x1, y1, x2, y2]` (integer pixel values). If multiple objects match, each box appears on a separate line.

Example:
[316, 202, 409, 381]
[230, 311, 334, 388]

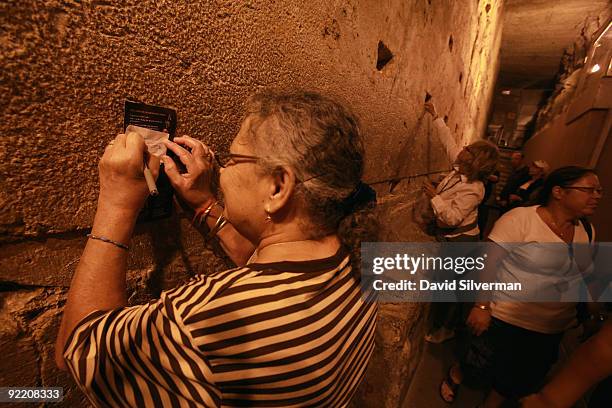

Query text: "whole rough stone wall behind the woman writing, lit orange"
[0, 0, 502, 407]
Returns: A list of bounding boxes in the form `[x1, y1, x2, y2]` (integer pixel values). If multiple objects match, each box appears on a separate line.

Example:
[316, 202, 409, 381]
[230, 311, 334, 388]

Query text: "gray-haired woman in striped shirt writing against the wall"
[57, 93, 376, 407]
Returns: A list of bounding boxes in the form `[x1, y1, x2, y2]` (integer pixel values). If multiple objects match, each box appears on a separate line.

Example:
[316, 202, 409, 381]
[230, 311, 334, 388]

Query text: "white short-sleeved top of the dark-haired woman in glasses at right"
[489, 205, 594, 333]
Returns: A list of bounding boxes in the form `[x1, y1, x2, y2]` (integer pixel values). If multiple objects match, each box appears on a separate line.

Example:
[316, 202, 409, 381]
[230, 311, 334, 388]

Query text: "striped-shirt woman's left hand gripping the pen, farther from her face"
[98, 132, 159, 213]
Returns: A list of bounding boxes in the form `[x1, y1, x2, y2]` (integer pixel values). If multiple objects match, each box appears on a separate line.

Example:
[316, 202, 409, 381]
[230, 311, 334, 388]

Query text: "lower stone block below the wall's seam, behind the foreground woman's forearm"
[0, 215, 230, 293]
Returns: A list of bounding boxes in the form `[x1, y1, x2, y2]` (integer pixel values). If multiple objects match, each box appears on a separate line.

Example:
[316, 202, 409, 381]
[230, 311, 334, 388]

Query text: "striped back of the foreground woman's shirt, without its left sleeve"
[177, 257, 376, 407]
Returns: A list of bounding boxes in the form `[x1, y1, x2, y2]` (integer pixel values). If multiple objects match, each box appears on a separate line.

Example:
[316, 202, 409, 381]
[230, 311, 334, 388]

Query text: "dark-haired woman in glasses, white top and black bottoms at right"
[440, 166, 602, 407]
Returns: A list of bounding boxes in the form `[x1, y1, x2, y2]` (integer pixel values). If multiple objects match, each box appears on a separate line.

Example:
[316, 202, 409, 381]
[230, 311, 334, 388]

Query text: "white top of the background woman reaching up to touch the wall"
[431, 118, 485, 238]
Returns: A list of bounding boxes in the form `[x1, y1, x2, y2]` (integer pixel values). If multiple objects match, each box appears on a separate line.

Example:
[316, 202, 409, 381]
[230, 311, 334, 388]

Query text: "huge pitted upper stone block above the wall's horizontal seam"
[0, 0, 501, 237]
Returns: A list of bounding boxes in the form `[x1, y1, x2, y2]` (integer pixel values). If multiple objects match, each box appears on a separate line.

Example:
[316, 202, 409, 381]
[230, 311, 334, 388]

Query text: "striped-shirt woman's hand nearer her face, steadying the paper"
[162, 136, 214, 210]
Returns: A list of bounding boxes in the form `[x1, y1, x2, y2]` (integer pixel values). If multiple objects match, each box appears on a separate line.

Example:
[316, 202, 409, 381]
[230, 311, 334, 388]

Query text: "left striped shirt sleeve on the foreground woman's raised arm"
[64, 279, 221, 407]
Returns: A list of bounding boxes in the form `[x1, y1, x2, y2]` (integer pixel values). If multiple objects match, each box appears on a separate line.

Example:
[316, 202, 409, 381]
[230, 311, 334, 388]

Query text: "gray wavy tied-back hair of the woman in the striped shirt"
[246, 92, 377, 274]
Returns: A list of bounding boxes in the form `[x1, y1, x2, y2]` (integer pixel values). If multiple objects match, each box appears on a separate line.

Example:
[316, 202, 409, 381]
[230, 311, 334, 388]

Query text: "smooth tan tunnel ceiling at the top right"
[499, 0, 612, 89]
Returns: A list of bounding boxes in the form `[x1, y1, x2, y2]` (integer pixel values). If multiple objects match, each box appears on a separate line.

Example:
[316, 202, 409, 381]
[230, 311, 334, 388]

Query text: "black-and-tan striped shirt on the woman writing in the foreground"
[64, 252, 377, 407]
